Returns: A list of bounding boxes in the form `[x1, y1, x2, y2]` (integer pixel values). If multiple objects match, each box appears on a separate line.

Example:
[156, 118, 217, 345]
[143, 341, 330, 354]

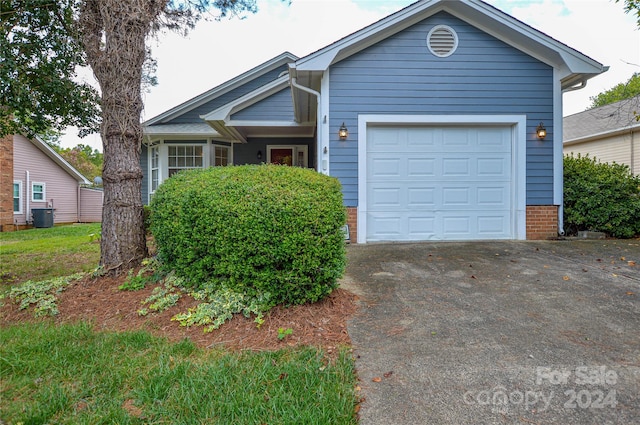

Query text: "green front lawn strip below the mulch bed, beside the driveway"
[0, 323, 356, 424]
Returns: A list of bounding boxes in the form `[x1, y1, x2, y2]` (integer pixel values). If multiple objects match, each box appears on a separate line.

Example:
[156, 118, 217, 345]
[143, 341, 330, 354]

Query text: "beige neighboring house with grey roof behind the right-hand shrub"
[563, 96, 640, 175]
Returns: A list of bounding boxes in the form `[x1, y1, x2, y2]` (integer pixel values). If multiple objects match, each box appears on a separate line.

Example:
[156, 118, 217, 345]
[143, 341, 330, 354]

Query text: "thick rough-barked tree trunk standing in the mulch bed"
[79, 0, 166, 273]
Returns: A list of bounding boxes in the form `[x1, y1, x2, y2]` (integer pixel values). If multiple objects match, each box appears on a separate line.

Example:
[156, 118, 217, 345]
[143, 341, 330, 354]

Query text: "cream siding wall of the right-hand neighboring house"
[563, 132, 640, 174]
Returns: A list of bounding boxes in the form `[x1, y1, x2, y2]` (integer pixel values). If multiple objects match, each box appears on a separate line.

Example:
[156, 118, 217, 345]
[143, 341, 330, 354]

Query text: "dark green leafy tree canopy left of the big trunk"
[0, 0, 100, 136]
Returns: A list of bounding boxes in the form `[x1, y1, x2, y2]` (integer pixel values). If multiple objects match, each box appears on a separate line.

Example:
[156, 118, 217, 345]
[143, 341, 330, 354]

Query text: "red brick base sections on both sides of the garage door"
[347, 205, 558, 243]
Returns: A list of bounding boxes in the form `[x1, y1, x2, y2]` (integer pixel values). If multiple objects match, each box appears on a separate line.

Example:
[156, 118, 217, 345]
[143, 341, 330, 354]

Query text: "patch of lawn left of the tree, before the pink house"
[0, 223, 100, 284]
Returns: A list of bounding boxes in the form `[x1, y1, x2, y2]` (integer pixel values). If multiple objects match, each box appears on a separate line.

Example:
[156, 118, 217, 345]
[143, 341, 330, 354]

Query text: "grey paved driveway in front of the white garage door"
[342, 240, 640, 425]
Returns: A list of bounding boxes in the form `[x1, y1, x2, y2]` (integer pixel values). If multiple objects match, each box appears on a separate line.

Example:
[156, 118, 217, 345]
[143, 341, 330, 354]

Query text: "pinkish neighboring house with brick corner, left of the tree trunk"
[0, 135, 103, 231]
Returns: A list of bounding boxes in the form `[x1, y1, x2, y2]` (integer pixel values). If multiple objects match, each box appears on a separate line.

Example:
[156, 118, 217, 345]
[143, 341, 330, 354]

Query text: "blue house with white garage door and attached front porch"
[141, 0, 606, 243]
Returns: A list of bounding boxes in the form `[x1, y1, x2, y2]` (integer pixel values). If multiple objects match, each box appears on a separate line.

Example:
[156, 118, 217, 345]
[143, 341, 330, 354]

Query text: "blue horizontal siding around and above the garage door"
[329, 12, 553, 206]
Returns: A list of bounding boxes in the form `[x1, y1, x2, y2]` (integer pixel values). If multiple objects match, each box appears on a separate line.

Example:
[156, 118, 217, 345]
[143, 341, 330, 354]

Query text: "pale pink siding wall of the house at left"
[13, 135, 79, 225]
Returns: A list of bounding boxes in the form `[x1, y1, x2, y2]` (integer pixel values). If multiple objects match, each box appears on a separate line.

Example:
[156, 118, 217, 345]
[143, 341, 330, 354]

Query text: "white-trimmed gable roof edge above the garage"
[294, 0, 608, 90]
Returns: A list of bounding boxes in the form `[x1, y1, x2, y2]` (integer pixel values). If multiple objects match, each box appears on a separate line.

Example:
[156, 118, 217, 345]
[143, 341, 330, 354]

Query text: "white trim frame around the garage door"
[357, 114, 527, 243]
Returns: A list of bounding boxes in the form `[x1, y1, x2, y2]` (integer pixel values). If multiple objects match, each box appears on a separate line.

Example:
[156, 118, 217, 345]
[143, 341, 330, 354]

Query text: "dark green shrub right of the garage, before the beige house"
[564, 155, 640, 238]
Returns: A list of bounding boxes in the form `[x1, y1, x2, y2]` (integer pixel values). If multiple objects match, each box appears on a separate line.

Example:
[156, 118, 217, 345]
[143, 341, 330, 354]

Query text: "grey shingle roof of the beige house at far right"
[563, 95, 640, 145]
